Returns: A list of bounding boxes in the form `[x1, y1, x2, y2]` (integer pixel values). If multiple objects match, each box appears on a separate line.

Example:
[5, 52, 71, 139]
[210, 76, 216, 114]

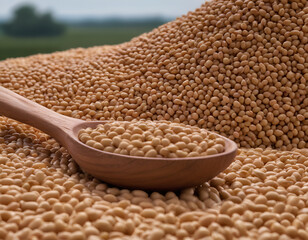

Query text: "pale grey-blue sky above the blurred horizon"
[0, 0, 205, 20]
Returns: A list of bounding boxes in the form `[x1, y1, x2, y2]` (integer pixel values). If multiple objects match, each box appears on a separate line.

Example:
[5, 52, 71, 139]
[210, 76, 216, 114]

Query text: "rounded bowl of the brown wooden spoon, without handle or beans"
[68, 121, 237, 190]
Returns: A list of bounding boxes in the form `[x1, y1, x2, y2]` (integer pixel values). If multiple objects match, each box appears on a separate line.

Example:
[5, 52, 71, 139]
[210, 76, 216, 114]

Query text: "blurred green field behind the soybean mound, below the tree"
[0, 26, 152, 60]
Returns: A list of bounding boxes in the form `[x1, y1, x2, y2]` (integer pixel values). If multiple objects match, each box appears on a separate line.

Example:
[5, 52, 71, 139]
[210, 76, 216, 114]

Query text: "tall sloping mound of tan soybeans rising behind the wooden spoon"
[0, 0, 308, 150]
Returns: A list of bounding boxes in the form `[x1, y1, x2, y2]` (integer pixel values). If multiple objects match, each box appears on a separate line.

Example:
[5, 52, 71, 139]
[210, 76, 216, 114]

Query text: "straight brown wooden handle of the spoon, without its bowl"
[0, 86, 81, 143]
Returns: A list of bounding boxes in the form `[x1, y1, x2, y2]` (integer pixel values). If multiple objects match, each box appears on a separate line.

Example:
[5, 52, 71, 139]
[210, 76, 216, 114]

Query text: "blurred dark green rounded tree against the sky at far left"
[2, 5, 65, 37]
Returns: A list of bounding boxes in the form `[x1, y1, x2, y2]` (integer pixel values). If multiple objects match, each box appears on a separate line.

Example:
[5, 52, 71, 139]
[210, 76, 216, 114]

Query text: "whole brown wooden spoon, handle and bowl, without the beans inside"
[0, 87, 237, 190]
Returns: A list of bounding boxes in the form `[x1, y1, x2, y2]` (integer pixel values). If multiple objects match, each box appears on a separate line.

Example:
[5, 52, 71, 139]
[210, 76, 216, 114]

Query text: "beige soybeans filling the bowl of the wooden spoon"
[79, 121, 225, 158]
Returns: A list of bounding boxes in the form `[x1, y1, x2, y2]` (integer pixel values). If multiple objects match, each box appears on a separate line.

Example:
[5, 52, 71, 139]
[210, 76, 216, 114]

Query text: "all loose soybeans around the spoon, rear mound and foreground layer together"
[0, 0, 308, 240]
